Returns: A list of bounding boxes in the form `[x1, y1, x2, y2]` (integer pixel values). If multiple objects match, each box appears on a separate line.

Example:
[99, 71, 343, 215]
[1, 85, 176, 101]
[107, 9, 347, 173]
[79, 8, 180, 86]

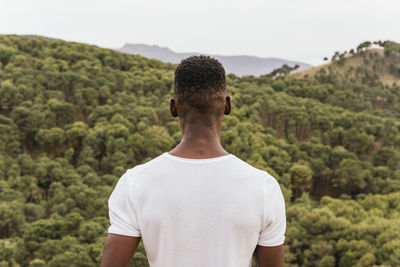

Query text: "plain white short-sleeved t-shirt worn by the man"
[108, 152, 286, 267]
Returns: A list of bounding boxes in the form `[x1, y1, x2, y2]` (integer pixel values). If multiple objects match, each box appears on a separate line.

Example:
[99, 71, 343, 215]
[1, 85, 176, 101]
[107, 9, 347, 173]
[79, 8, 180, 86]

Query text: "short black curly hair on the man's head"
[174, 55, 226, 109]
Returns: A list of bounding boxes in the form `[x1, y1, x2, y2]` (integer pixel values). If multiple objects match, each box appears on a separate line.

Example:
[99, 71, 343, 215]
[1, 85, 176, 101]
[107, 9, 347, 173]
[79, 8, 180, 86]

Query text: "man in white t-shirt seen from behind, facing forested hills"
[101, 56, 286, 267]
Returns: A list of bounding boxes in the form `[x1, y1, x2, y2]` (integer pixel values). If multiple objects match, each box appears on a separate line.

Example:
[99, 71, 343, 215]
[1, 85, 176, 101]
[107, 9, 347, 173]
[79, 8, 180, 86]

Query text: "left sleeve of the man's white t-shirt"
[108, 171, 141, 237]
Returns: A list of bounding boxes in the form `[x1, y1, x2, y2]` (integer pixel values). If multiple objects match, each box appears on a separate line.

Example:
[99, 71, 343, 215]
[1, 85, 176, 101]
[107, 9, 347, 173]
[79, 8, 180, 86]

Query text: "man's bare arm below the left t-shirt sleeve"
[100, 234, 140, 267]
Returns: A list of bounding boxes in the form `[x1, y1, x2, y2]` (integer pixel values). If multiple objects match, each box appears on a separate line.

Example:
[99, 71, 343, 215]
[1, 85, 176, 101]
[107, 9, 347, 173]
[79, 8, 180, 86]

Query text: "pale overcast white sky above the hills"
[0, 0, 400, 65]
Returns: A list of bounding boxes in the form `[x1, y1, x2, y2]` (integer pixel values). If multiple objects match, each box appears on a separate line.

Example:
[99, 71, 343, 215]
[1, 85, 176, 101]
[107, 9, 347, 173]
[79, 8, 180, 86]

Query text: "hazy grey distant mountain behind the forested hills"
[116, 44, 312, 76]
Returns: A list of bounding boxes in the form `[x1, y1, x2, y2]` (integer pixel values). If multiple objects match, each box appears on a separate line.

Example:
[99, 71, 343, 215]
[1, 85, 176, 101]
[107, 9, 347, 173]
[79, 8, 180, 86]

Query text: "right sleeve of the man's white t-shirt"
[257, 177, 286, 247]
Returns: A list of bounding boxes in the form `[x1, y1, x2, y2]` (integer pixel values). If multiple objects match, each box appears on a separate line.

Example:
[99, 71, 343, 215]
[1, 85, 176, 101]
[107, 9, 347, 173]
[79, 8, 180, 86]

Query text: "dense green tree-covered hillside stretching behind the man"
[0, 35, 400, 267]
